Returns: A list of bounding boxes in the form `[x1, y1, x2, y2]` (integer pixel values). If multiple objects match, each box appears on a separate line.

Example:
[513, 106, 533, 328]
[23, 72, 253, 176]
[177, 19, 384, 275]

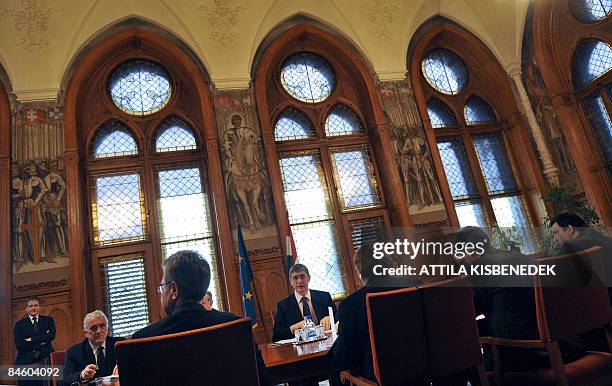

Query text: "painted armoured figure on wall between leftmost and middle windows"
[222, 114, 271, 229]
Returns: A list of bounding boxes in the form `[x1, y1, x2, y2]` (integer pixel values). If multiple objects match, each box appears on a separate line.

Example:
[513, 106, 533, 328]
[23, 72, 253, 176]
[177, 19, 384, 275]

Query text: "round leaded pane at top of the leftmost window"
[108, 60, 172, 115]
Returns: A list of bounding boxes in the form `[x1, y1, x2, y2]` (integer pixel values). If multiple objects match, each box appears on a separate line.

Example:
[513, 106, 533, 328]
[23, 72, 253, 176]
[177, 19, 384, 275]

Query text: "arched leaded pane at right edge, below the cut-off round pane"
[572, 39, 612, 89]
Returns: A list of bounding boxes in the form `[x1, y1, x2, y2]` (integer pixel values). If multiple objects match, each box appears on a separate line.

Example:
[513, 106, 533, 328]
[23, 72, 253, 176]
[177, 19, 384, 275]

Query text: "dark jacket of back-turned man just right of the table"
[332, 287, 392, 380]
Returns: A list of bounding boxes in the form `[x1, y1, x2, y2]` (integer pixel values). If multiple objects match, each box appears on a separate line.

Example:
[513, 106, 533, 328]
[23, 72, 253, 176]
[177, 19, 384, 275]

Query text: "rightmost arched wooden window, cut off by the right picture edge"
[531, 0, 612, 224]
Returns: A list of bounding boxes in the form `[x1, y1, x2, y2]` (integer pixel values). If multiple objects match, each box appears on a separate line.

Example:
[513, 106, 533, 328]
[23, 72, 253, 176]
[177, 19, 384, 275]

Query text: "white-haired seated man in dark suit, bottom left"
[60, 310, 124, 386]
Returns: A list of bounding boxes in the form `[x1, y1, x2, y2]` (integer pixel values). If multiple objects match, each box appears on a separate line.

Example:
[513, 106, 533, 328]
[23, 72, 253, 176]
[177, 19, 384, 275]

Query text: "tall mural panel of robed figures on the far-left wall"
[11, 102, 69, 274]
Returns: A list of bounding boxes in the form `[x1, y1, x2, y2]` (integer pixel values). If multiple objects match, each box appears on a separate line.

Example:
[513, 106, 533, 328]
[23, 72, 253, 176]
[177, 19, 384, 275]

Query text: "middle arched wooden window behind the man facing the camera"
[255, 25, 407, 298]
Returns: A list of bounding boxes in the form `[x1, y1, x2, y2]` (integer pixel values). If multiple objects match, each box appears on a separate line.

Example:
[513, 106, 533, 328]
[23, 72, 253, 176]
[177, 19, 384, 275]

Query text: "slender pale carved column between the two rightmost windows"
[506, 63, 559, 185]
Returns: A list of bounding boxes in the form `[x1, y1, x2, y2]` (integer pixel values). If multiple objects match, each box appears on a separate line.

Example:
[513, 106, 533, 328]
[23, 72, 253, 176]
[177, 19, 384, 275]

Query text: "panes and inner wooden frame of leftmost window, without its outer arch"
[80, 53, 224, 335]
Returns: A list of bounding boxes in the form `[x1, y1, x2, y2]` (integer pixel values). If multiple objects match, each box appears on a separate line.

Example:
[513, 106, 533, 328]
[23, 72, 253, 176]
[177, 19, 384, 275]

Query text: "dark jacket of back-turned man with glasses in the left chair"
[132, 303, 270, 386]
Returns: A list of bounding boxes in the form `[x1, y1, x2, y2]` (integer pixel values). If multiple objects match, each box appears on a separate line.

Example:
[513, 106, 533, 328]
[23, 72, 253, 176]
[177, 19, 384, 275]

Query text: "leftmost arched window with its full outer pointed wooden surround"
[65, 27, 232, 334]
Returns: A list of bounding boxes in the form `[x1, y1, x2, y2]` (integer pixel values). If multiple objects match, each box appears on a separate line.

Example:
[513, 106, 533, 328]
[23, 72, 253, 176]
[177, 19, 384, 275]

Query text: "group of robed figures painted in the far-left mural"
[11, 159, 68, 272]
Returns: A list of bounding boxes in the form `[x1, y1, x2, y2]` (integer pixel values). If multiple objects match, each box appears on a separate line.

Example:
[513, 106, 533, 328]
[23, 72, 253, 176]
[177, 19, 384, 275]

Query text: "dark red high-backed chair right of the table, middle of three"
[341, 279, 488, 386]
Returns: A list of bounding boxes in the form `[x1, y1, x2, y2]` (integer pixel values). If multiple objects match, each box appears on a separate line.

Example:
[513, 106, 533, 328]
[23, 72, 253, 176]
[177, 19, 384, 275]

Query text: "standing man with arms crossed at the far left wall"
[13, 297, 55, 385]
